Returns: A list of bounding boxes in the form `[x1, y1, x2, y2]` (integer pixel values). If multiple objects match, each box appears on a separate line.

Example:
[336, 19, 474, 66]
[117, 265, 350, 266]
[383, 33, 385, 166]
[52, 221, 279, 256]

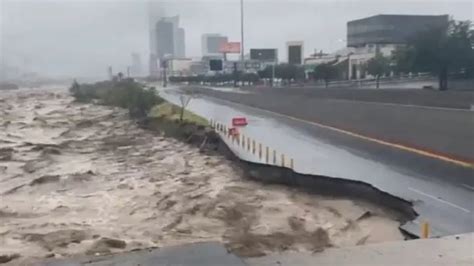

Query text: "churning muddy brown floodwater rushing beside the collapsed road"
[0, 90, 403, 263]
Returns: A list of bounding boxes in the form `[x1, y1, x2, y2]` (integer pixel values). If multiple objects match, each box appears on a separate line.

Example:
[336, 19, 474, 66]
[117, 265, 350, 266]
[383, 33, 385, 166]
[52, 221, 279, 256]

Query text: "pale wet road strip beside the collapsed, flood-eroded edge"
[161, 87, 474, 236]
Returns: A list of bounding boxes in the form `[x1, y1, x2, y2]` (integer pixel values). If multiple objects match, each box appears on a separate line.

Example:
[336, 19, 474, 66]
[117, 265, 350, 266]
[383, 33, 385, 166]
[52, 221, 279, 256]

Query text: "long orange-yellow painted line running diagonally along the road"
[211, 96, 474, 168]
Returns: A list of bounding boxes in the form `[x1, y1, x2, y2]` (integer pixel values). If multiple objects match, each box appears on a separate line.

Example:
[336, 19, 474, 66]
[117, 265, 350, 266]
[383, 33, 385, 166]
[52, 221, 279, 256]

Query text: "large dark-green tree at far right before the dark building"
[394, 20, 474, 90]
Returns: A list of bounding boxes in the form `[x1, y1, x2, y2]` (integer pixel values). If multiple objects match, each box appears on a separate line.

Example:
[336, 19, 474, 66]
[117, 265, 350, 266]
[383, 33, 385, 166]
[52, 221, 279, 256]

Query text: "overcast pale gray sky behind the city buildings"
[0, 0, 474, 76]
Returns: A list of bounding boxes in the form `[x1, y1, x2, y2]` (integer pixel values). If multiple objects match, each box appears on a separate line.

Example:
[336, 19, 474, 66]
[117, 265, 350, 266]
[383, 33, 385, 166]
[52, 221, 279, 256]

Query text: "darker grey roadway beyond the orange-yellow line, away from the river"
[187, 87, 474, 164]
